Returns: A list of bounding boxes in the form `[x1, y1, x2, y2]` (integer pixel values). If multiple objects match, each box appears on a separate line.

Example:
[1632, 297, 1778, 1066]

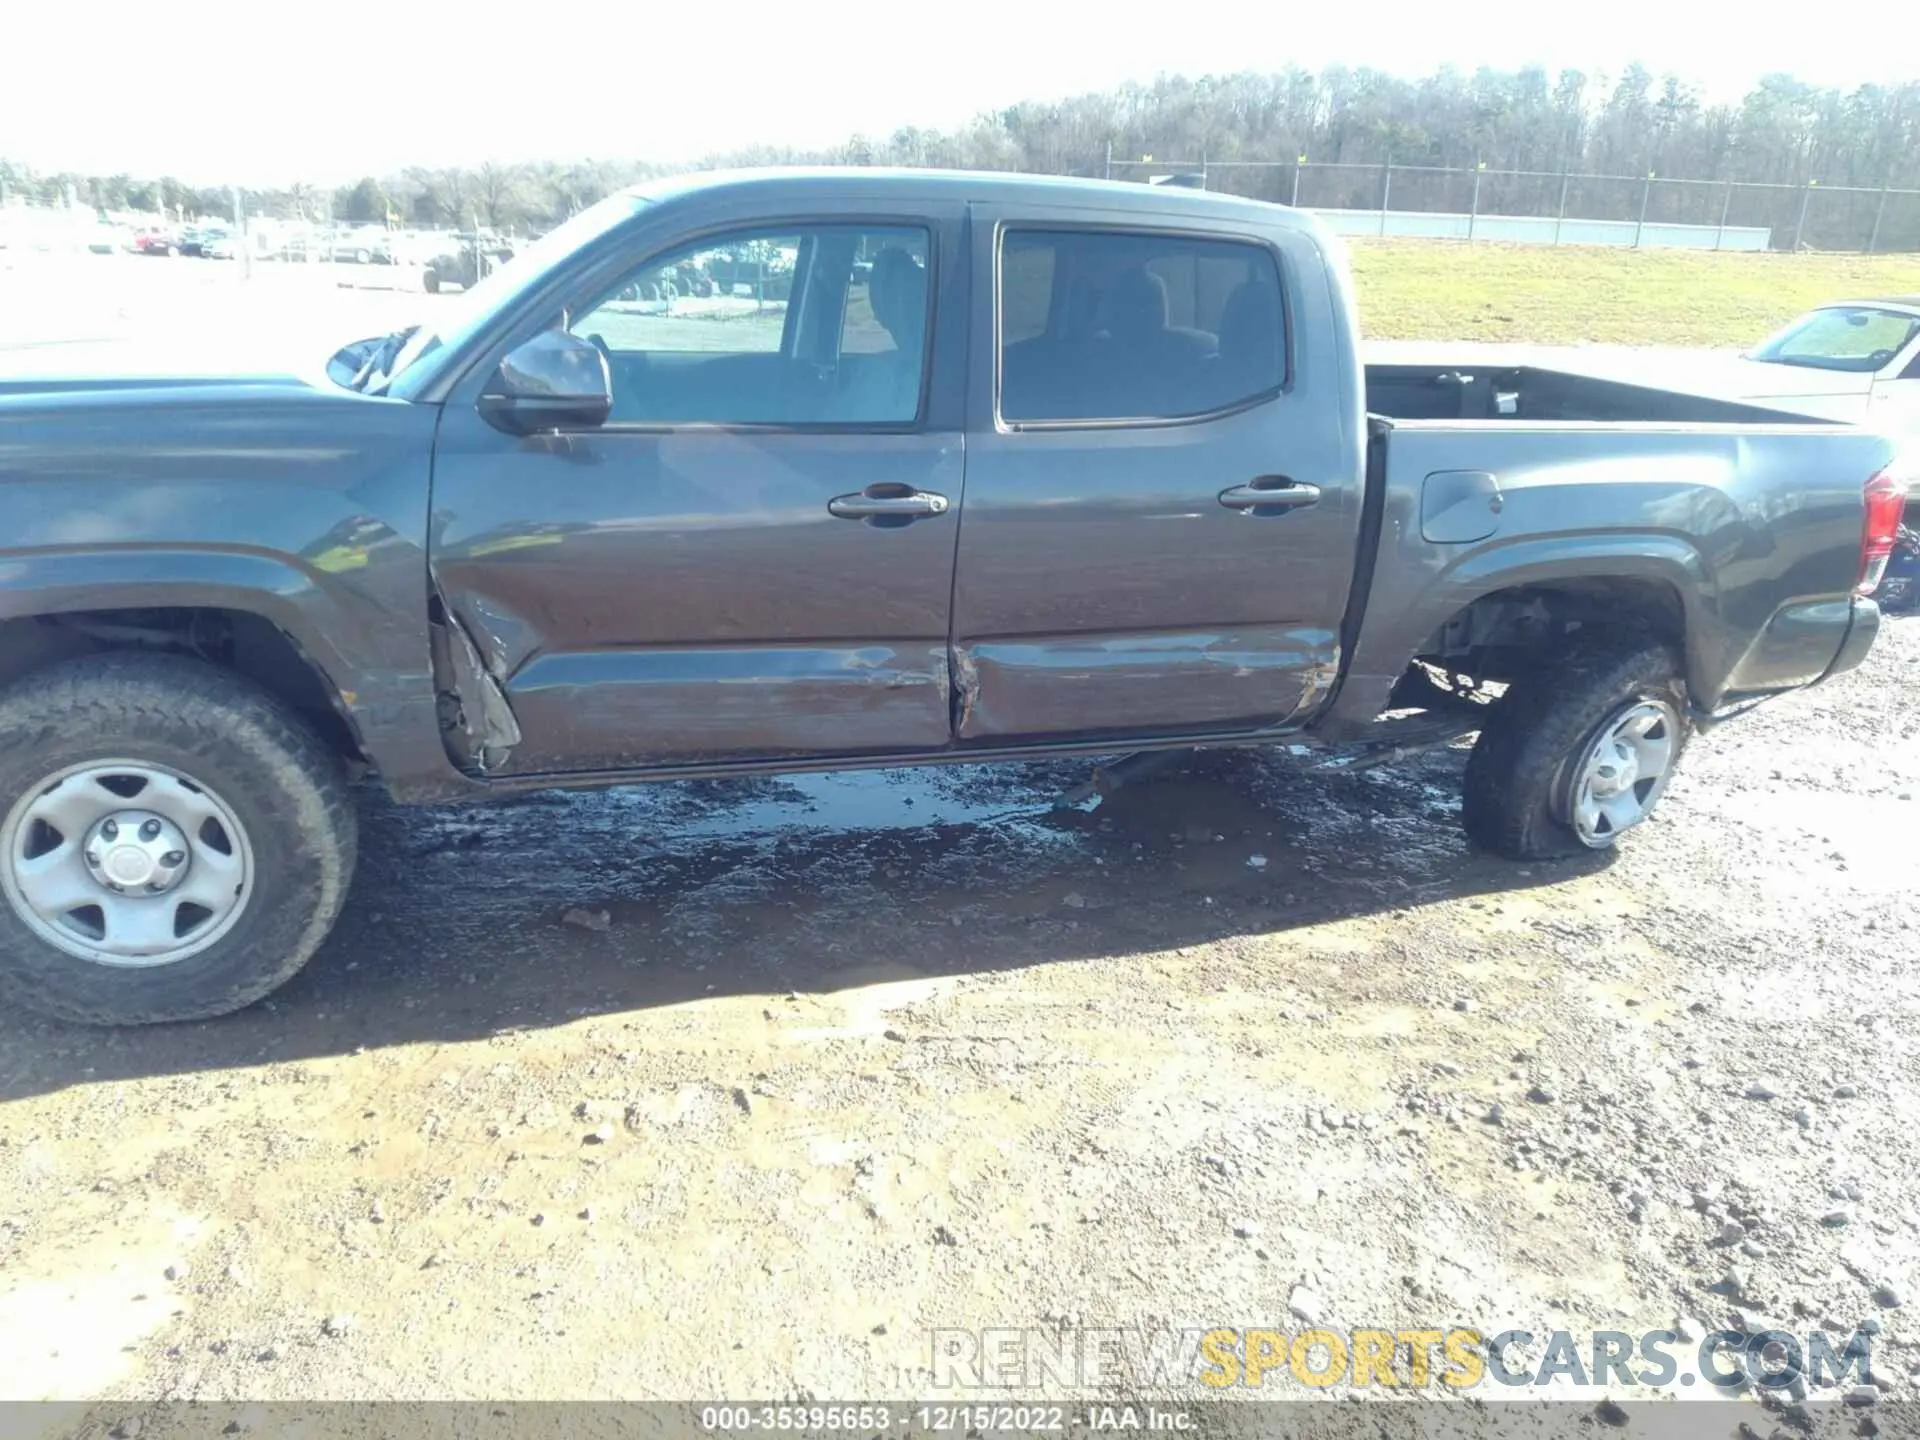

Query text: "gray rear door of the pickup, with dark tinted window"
[954, 205, 1363, 743]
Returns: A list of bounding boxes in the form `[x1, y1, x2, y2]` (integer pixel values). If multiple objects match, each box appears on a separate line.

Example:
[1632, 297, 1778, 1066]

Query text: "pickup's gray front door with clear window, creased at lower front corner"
[432, 211, 966, 774]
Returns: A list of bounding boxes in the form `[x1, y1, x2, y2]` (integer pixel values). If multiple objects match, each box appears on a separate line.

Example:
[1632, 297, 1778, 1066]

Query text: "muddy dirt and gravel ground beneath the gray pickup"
[0, 595, 1920, 1434]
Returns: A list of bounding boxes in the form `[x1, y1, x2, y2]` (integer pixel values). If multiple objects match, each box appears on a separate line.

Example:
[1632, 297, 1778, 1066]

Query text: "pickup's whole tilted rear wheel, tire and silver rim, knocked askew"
[1461, 641, 1690, 860]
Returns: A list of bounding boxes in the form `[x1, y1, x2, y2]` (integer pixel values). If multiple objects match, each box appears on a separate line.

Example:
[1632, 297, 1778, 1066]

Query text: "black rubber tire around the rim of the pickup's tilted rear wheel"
[1461, 637, 1690, 860]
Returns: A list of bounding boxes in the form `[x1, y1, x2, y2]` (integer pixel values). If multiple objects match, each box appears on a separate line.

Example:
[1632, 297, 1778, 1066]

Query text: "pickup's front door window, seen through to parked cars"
[568, 225, 931, 426]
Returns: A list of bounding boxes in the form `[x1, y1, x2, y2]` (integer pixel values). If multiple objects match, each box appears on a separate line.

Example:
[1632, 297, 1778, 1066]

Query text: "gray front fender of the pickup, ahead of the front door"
[0, 384, 457, 793]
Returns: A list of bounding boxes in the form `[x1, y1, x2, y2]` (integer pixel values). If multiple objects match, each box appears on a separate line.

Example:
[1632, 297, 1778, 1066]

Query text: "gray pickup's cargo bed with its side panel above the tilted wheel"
[1325, 363, 1889, 748]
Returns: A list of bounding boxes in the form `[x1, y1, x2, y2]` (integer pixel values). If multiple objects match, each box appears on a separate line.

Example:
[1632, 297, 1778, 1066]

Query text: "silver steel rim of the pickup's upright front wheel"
[0, 760, 253, 970]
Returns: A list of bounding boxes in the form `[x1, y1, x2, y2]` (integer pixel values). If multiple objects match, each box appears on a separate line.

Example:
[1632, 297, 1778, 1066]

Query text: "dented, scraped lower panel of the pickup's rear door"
[954, 628, 1340, 739]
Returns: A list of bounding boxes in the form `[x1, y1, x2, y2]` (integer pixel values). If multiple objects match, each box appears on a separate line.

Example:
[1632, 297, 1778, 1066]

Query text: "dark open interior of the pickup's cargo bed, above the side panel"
[1367, 365, 1832, 424]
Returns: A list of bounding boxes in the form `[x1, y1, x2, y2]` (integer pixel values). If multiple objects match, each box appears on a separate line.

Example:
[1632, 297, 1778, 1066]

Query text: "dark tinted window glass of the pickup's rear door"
[1000, 230, 1286, 422]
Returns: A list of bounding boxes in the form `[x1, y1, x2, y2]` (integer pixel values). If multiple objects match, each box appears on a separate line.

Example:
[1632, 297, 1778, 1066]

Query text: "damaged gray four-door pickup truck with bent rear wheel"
[0, 171, 1901, 1023]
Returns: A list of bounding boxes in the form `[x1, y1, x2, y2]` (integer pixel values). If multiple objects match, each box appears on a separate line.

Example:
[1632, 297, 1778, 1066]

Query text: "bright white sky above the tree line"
[0, 0, 1920, 186]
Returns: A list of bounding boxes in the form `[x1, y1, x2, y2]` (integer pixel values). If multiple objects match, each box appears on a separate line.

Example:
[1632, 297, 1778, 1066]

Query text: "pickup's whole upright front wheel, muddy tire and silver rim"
[0, 653, 355, 1025]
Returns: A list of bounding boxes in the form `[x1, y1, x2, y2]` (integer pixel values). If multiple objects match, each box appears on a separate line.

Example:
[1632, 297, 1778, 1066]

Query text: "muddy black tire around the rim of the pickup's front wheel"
[0, 653, 357, 1025]
